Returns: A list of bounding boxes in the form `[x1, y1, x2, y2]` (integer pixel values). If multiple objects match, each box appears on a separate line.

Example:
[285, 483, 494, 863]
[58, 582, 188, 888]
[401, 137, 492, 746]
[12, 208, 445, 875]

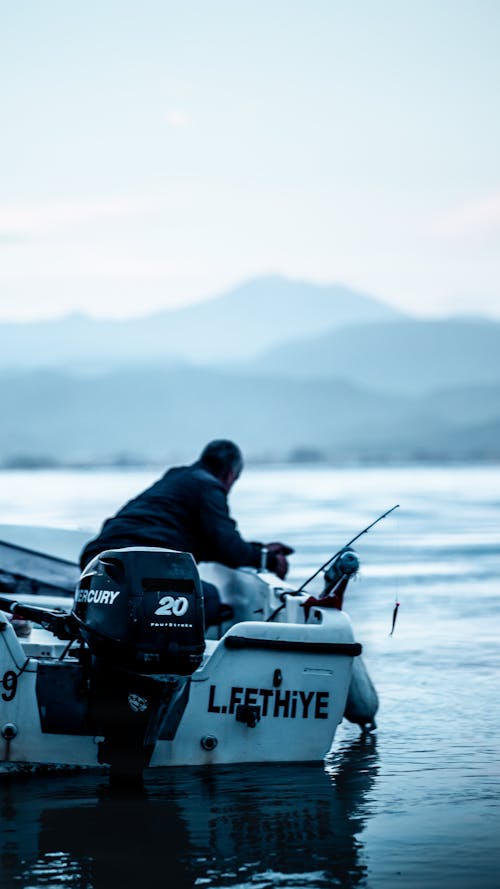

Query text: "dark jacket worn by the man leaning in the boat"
[80, 463, 262, 568]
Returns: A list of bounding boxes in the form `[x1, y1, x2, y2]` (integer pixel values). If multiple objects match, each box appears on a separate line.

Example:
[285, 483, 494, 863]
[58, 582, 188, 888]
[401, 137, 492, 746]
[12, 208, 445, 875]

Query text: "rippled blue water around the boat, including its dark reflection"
[0, 467, 500, 889]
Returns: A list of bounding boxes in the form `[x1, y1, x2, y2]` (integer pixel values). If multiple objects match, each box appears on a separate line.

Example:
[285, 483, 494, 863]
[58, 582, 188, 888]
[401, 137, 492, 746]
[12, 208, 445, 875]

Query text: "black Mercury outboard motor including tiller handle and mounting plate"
[0, 547, 205, 778]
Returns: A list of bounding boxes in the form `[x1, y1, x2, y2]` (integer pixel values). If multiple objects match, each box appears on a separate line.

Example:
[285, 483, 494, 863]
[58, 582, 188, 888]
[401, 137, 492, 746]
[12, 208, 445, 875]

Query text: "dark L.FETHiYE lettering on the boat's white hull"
[207, 685, 330, 719]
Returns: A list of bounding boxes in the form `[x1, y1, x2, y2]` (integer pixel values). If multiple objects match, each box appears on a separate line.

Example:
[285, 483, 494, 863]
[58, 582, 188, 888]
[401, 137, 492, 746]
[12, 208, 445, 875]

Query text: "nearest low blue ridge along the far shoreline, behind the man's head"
[0, 368, 500, 465]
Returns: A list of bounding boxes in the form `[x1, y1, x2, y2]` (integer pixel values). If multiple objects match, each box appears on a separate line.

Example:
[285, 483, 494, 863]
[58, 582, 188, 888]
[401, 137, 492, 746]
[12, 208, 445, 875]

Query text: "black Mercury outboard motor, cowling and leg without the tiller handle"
[71, 547, 205, 777]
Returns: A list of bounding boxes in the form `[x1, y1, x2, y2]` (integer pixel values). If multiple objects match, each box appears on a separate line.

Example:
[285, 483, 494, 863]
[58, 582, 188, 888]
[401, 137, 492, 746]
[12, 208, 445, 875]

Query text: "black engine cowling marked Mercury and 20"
[72, 547, 205, 675]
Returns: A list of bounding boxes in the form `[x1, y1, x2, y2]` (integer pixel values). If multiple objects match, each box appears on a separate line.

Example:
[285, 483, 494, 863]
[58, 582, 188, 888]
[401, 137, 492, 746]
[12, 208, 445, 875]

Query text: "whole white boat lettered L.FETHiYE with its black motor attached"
[0, 532, 378, 772]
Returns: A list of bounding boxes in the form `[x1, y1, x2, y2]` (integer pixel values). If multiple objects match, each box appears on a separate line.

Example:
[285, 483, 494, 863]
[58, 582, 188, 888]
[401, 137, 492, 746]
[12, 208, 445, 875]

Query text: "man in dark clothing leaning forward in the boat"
[80, 439, 293, 625]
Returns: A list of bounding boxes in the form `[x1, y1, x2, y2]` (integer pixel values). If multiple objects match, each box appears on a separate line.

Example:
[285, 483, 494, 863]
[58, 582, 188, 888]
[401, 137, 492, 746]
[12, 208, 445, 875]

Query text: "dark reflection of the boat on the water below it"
[0, 736, 377, 889]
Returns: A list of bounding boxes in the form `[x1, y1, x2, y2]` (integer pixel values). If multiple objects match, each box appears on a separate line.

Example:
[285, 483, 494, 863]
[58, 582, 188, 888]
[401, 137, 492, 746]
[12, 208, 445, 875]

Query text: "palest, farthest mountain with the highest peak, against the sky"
[0, 277, 404, 373]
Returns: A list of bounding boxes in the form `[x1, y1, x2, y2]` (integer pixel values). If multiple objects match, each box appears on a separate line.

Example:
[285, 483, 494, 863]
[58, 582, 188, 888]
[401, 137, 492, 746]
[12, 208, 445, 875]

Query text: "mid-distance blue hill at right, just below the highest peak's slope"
[246, 318, 500, 394]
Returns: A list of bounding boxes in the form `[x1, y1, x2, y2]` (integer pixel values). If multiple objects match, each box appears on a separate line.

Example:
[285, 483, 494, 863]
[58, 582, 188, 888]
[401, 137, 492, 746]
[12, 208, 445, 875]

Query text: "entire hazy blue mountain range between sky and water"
[0, 278, 500, 465]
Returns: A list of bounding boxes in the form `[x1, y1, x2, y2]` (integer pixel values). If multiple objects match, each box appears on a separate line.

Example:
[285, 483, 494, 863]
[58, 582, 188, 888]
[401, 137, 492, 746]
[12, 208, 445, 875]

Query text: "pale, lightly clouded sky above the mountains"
[0, 0, 500, 320]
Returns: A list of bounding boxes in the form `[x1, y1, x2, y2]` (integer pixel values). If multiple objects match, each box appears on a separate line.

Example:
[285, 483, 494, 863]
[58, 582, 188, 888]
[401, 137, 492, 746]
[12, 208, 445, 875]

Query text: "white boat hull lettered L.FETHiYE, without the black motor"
[0, 610, 360, 766]
